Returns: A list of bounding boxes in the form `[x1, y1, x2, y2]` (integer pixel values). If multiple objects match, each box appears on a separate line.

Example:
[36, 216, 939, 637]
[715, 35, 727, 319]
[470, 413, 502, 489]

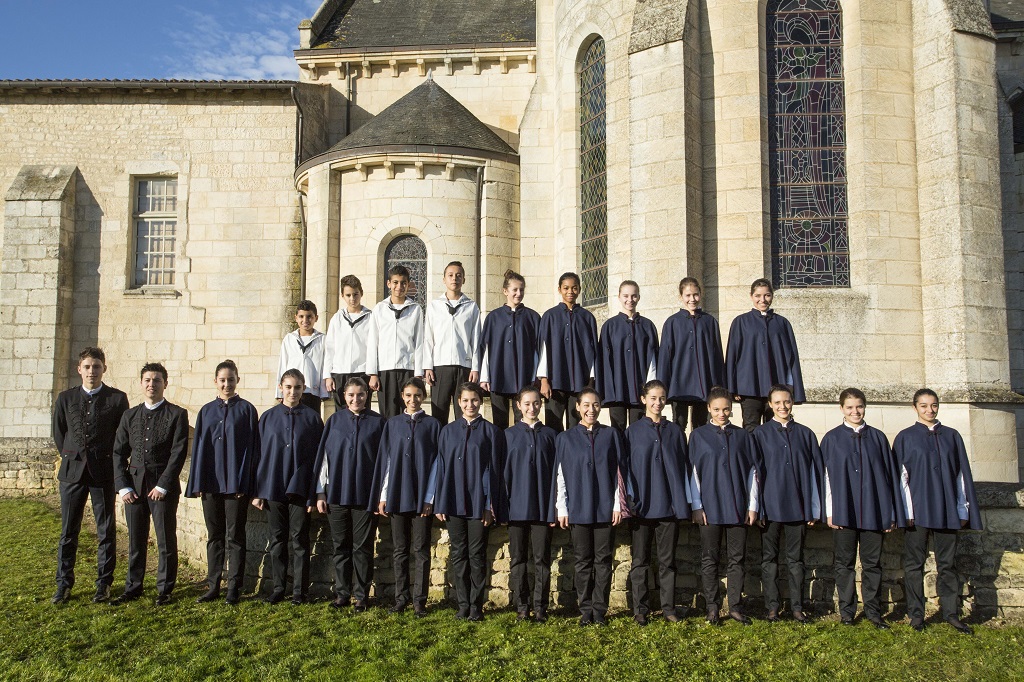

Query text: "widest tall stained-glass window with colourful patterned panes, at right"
[767, 0, 850, 287]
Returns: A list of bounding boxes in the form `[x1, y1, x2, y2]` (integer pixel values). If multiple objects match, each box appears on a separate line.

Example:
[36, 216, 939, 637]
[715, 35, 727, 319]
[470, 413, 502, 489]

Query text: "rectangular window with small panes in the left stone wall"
[132, 177, 178, 288]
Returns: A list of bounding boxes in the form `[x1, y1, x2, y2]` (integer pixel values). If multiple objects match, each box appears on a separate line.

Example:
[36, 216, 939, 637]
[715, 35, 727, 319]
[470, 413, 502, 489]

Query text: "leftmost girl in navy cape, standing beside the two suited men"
[185, 359, 259, 604]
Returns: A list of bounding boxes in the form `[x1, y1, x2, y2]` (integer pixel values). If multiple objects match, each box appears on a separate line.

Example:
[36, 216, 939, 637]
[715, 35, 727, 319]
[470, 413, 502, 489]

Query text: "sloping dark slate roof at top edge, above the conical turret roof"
[311, 0, 537, 49]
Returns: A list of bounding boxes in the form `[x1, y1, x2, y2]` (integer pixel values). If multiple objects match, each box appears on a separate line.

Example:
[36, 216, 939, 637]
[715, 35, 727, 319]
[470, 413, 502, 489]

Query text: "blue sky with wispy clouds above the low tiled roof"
[0, 0, 321, 80]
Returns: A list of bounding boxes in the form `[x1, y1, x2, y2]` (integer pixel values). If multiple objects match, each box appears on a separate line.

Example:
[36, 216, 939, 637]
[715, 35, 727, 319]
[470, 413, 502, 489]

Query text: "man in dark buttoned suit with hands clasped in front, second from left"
[114, 363, 188, 606]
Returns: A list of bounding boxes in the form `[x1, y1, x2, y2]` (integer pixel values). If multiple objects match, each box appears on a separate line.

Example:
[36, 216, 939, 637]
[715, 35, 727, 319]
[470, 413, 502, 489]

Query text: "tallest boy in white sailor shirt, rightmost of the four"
[423, 260, 480, 426]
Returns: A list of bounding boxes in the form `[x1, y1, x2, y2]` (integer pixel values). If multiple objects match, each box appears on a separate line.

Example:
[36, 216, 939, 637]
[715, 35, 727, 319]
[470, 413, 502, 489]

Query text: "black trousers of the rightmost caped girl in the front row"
[903, 525, 959, 620]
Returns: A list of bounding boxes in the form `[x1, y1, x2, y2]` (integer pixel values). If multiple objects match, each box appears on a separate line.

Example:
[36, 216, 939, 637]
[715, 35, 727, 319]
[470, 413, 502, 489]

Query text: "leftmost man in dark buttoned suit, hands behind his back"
[50, 347, 128, 604]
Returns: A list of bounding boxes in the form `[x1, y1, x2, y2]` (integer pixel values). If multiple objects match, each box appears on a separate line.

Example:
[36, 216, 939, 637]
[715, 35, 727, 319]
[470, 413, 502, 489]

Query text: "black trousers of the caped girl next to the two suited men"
[203, 493, 249, 591]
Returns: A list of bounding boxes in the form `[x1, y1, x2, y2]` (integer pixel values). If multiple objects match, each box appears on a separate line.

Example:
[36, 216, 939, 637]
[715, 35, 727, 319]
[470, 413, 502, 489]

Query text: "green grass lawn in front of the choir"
[0, 500, 1024, 682]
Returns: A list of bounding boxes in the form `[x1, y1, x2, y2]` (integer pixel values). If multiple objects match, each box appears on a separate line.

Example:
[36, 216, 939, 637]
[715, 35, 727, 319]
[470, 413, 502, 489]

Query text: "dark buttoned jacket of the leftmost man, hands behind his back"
[53, 384, 128, 483]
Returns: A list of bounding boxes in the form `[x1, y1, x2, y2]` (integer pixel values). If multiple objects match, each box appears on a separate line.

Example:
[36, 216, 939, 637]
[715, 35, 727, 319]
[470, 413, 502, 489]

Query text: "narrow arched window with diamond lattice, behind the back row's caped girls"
[580, 38, 608, 306]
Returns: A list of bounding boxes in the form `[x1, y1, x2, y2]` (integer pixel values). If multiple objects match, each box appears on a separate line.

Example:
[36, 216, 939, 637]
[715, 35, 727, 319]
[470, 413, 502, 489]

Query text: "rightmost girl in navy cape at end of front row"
[893, 388, 982, 634]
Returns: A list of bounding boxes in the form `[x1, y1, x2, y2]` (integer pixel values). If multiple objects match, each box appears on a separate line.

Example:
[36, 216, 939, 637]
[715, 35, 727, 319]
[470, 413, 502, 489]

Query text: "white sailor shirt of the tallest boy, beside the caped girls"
[423, 294, 480, 372]
